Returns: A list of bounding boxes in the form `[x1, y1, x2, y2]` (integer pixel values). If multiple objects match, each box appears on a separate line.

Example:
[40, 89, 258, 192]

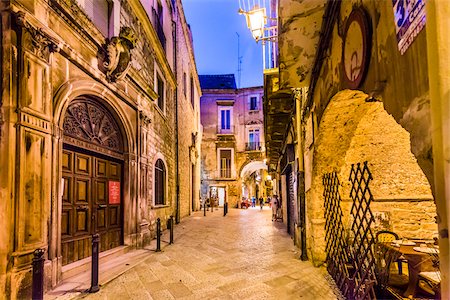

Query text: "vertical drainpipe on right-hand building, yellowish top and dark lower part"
[294, 88, 308, 261]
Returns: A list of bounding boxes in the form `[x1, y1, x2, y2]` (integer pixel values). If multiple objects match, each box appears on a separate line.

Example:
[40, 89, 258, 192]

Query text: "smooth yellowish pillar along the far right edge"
[426, 0, 450, 299]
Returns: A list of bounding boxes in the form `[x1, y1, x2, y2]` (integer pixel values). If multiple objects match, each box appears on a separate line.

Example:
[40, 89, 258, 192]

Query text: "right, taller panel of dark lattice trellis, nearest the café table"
[348, 161, 376, 299]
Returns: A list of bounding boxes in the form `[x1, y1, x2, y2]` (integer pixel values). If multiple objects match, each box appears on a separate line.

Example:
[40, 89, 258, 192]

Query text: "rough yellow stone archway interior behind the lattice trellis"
[307, 90, 437, 261]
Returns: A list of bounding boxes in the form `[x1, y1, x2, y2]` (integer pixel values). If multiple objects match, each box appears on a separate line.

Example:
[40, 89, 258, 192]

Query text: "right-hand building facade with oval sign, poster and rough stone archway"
[264, 0, 449, 295]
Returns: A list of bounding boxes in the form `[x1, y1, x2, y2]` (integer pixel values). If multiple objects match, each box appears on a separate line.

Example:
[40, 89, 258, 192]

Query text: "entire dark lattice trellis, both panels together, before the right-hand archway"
[323, 162, 376, 300]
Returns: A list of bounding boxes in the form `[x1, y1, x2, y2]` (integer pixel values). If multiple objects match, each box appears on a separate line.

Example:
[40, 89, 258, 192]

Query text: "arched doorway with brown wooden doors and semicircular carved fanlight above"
[61, 96, 124, 265]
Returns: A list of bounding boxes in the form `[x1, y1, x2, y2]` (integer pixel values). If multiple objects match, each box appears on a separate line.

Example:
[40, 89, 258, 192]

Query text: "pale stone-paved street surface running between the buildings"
[78, 207, 340, 299]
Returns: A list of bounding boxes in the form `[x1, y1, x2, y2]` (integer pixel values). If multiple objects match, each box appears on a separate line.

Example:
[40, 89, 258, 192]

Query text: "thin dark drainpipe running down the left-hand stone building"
[172, 15, 180, 224]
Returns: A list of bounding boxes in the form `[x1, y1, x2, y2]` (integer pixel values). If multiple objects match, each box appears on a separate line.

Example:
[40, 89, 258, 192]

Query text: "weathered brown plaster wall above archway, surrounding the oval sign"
[310, 0, 432, 182]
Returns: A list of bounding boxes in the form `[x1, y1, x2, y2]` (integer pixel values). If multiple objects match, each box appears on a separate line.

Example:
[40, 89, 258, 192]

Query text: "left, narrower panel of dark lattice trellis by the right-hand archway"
[322, 172, 349, 290]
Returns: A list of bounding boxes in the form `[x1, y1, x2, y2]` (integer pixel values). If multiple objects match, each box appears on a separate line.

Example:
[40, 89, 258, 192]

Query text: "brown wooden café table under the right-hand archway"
[385, 241, 435, 298]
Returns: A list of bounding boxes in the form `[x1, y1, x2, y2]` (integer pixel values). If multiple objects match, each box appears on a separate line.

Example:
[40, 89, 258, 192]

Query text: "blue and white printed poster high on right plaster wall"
[392, 0, 425, 55]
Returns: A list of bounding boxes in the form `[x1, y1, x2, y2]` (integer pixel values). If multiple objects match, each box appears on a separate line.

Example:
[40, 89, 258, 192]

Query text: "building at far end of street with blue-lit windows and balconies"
[199, 74, 270, 207]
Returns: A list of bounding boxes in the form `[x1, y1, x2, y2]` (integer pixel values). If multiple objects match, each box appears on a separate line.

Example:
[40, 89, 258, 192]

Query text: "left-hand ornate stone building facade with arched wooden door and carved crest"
[0, 0, 201, 299]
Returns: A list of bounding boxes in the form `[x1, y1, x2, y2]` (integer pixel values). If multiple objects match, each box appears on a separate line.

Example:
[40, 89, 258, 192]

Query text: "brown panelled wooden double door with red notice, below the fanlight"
[61, 147, 123, 265]
